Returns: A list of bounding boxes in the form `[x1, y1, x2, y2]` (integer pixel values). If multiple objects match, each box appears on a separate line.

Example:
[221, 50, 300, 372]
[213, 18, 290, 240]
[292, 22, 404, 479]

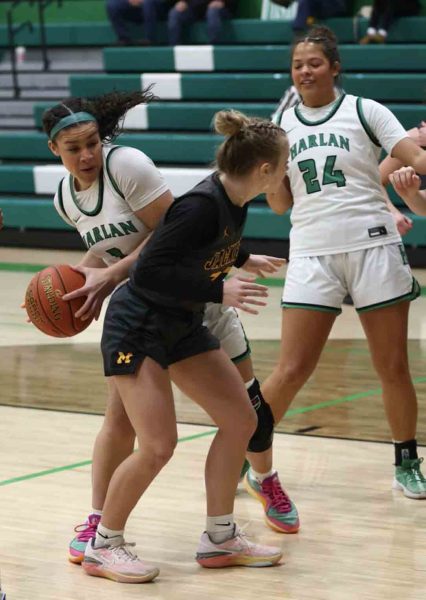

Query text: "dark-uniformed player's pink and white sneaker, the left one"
[81, 538, 160, 583]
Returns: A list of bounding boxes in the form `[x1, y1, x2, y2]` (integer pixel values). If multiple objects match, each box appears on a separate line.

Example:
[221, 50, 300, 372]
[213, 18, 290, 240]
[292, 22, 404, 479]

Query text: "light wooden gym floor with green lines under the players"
[0, 248, 426, 600]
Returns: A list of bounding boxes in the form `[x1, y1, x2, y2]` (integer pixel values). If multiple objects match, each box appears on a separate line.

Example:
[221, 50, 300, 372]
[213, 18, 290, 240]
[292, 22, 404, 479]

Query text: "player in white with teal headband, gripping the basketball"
[43, 92, 299, 563]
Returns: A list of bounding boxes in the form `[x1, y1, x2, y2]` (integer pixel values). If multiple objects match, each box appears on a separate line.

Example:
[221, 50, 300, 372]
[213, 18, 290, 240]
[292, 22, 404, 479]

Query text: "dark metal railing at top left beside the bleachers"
[6, 0, 62, 98]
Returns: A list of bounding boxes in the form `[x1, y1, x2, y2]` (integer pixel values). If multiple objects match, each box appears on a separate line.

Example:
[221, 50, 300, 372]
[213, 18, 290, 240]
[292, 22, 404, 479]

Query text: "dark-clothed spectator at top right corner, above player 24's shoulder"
[359, 0, 421, 45]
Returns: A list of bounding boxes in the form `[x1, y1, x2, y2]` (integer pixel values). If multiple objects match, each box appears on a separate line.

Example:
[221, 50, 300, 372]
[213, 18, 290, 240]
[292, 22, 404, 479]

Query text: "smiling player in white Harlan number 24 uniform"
[248, 27, 426, 498]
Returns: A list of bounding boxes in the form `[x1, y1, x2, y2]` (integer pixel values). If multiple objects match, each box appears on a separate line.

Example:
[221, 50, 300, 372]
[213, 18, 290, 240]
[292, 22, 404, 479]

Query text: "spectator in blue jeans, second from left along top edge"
[168, 0, 238, 46]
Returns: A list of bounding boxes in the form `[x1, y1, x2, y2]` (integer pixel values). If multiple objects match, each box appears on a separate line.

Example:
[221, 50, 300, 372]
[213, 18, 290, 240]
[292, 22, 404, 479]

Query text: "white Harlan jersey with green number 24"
[281, 94, 407, 257]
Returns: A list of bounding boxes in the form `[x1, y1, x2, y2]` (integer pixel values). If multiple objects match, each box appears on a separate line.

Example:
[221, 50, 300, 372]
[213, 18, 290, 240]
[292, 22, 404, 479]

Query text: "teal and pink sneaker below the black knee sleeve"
[244, 470, 300, 533]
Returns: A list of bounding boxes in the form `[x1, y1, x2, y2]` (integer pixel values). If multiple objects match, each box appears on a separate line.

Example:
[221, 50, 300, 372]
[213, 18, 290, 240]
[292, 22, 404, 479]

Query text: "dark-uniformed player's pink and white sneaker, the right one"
[195, 526, 282, 569]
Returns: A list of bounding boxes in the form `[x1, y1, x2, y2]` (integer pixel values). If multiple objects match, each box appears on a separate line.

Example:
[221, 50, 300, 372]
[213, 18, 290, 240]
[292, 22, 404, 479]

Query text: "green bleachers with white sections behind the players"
[0, 8, 426, 251]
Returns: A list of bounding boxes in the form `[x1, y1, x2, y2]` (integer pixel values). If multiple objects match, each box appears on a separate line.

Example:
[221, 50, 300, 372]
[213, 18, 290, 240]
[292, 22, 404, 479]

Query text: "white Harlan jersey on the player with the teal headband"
[54, 146, 168, 265]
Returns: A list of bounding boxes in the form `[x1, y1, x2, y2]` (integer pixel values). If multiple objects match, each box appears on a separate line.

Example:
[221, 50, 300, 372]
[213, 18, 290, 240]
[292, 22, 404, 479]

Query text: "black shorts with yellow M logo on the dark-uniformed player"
[101, 284, 220, 376]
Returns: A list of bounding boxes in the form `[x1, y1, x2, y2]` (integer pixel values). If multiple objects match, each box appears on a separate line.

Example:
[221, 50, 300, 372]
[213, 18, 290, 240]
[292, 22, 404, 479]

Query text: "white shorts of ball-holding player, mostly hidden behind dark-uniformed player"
[203, 302, 251, 362]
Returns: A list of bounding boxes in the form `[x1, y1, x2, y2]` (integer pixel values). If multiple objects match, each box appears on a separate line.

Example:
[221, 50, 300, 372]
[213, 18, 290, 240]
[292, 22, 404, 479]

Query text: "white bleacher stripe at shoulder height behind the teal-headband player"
[33, 165, 212, 196]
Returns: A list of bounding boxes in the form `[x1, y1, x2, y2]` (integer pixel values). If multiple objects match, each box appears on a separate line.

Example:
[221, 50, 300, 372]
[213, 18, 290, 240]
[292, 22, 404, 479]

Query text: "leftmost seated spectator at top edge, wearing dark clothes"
[106, 0, 170, 46]
